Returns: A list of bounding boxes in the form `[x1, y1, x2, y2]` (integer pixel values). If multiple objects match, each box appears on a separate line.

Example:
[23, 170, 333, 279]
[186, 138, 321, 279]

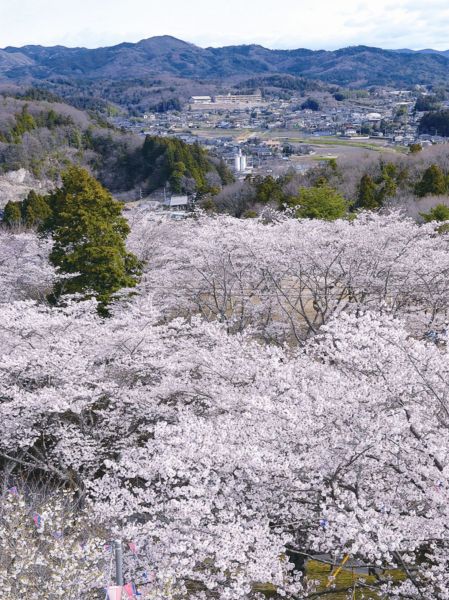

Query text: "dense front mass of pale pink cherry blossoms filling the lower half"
[1, 299, 448, 598]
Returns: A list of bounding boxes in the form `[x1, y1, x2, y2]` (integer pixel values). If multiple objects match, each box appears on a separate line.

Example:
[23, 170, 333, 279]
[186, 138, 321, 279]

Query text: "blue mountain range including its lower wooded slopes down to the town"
[4, 36, 449, 115]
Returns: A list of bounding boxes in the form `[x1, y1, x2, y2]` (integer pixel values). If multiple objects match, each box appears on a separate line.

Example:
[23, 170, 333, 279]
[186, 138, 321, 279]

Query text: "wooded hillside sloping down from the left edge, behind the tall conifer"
[0, 89, 232, 193]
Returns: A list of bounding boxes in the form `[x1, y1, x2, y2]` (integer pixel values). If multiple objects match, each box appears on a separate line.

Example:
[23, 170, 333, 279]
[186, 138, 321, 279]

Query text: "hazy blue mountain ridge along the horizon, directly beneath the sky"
[0, 36, 449, 86]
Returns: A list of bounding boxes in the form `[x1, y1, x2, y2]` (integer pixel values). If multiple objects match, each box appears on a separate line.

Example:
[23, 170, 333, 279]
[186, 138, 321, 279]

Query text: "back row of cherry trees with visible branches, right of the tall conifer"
[131, 213, 449, 343]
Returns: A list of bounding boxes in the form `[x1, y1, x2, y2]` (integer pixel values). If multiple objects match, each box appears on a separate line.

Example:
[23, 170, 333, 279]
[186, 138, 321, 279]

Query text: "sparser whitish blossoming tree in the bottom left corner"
[0, 487, 107, 600]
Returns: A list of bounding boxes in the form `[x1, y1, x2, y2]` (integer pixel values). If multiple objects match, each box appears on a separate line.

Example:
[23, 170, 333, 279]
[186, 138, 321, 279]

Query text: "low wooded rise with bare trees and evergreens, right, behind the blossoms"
[206, 144, 449, 220]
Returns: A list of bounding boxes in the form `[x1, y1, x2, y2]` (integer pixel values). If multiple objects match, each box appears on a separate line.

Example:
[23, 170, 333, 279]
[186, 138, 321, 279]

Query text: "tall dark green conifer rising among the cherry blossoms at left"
[44, 166, 141, 315]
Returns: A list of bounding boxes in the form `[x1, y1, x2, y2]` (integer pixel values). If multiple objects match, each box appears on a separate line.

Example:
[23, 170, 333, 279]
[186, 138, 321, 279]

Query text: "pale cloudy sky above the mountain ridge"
[0, 0, 449, 50]
